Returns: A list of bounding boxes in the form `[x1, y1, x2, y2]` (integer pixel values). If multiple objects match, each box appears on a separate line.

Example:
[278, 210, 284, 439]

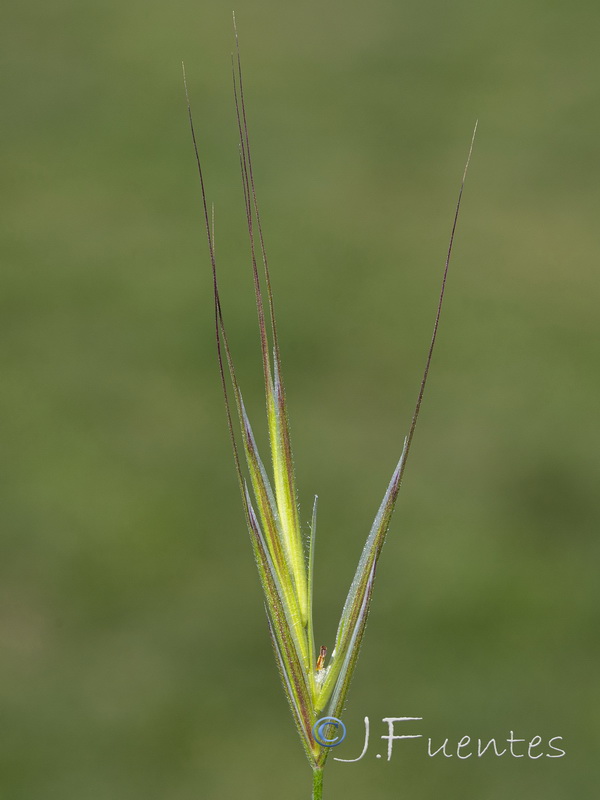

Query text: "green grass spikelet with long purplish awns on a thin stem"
[184, 20, 477, 798]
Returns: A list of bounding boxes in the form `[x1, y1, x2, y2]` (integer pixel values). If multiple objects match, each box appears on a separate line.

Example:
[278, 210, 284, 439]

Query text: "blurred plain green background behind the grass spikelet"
[0, 0, 600, 800]
